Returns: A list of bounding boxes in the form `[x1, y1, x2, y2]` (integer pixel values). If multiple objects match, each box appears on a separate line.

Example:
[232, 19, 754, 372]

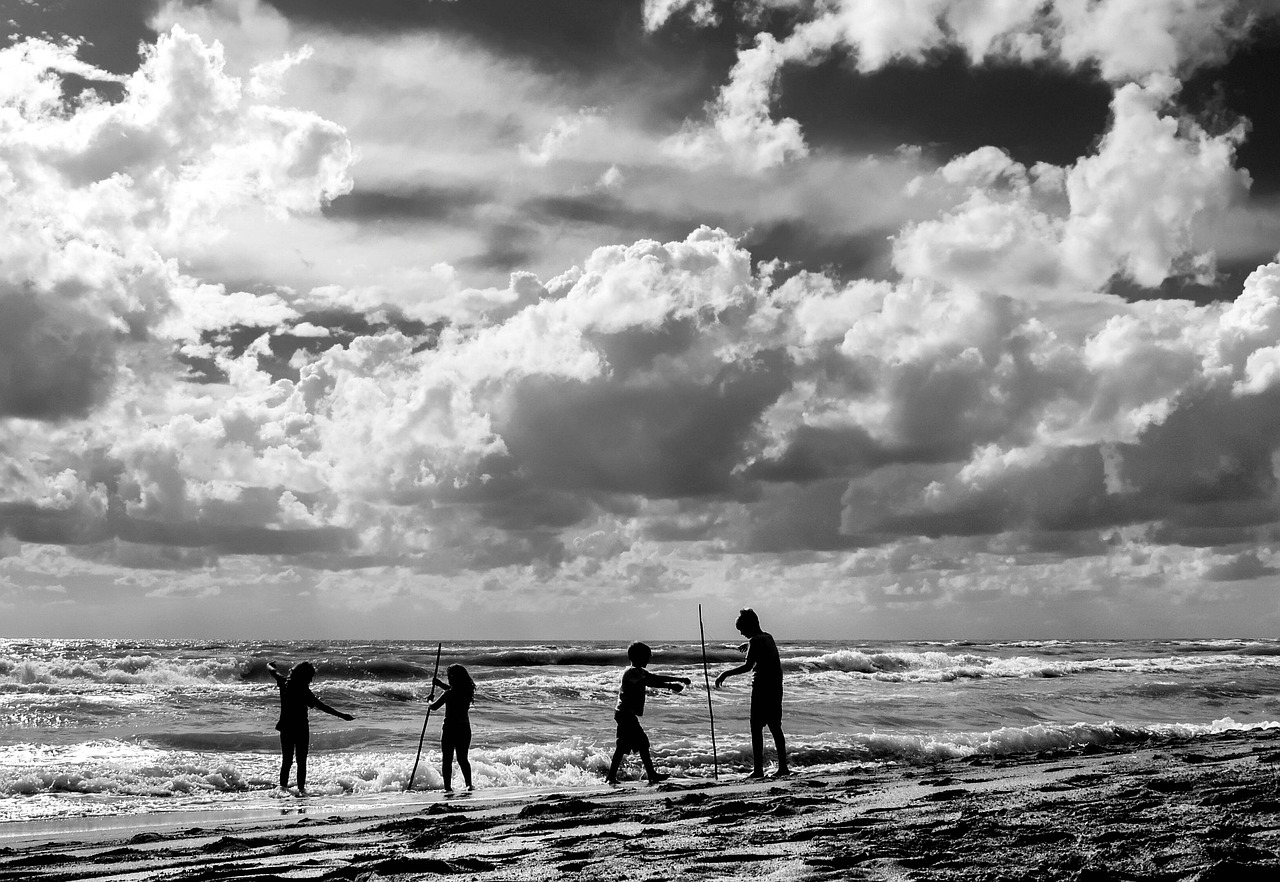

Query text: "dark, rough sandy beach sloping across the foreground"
[0, 732, 1280, 882]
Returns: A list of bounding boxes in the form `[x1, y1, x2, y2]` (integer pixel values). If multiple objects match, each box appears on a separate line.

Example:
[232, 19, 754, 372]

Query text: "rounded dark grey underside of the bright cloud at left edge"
[0, 288, 115, 420]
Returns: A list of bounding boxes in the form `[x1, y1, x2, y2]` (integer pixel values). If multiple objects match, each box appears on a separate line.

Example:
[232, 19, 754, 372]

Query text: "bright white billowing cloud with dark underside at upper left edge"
[0, 28, 351, 419]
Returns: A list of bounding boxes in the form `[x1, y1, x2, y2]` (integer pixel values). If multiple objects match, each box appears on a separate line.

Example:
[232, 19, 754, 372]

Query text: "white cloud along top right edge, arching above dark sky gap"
[665, 0, 1280, 170]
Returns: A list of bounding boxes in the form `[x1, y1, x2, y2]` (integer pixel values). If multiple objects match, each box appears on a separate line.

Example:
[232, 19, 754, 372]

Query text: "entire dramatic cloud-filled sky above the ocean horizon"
[0, 0, 1280, 640]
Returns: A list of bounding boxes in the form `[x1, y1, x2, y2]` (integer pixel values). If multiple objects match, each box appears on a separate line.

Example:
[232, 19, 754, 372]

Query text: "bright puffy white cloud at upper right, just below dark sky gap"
[893, 78, 1249, 300]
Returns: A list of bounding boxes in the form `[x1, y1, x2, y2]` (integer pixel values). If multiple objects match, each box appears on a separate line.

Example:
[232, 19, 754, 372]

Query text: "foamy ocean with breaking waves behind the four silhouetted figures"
[0, 635, 1280, 822]
